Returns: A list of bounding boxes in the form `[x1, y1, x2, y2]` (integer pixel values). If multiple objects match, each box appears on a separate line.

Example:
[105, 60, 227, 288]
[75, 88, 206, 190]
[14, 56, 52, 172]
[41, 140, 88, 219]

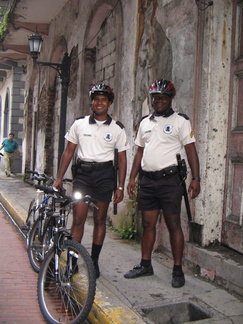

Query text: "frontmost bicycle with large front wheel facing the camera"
[37, 186, 98, 324]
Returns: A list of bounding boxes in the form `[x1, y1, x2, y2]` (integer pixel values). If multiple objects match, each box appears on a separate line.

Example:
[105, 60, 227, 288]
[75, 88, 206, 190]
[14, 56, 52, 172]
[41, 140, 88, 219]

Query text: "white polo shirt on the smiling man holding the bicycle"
[65, 115, 130, 162]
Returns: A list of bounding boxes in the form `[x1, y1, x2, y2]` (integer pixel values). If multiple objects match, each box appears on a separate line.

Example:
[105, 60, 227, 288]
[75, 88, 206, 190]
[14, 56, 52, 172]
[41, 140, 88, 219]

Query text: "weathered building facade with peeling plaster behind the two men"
[0, 0, 243, 276]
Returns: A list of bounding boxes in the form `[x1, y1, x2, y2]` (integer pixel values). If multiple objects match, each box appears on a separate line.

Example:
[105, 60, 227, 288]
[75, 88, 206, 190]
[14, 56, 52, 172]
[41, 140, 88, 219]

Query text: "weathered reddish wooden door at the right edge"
[222, 0, 243, 253]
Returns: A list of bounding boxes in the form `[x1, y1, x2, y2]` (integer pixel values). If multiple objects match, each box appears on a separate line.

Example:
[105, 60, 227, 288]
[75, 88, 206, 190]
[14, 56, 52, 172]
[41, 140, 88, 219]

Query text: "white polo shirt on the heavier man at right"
[135, 112, 195, 171]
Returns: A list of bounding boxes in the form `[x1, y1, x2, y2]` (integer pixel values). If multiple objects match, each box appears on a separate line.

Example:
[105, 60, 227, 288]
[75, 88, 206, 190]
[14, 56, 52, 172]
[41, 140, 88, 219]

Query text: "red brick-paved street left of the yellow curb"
[0, 208, 46, 324]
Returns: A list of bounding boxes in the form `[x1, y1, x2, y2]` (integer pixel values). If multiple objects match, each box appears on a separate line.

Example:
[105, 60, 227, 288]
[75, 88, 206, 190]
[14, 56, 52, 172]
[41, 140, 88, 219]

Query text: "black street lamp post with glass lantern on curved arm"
[28, 31, 71, 167]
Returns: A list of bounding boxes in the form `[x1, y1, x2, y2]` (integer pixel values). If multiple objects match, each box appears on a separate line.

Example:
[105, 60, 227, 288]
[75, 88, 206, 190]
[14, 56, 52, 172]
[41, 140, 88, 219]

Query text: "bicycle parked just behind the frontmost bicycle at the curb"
[27, 179, 72, 272]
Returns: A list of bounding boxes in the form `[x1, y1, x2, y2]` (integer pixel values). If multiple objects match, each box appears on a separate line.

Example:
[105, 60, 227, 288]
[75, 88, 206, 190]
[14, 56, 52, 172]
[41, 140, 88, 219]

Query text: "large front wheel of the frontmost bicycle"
[37, 240, 96, 324]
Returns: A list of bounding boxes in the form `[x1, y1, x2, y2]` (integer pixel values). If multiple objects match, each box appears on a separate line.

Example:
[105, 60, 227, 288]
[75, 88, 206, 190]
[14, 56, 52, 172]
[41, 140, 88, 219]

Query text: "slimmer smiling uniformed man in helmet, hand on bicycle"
[54, 84, 129, 278]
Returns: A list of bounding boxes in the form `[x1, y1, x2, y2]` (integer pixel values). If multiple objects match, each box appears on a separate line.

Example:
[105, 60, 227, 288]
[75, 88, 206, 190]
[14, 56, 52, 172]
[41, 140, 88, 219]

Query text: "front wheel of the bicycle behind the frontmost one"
[27, 218, 52, 272]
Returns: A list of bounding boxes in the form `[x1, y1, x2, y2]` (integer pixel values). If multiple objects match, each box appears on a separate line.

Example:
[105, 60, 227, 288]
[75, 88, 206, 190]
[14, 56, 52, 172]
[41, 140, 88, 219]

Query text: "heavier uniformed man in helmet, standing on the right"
[124, 79, 200, 288]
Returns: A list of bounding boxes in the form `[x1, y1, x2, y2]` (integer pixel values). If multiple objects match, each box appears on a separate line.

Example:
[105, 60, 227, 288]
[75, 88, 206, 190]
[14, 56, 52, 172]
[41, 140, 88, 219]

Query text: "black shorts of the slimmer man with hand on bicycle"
[73, 167, 114, 203]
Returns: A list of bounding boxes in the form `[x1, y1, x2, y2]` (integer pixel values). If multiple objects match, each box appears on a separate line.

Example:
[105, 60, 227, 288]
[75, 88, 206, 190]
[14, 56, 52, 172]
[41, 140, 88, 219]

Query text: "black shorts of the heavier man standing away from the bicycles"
[138, 174, 184, 214]
